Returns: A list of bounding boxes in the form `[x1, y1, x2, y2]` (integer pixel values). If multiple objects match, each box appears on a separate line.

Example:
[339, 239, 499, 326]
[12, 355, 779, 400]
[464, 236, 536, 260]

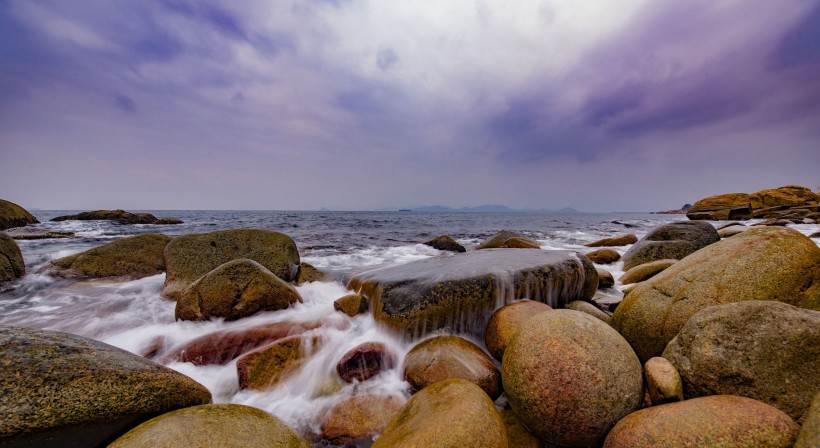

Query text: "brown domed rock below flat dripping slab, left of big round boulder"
[404, 336, 501, 400]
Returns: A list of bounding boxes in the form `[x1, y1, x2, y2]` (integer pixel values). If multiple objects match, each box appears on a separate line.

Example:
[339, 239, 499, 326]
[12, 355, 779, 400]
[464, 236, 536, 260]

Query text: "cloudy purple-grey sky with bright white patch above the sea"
[0, 0, 820, 211]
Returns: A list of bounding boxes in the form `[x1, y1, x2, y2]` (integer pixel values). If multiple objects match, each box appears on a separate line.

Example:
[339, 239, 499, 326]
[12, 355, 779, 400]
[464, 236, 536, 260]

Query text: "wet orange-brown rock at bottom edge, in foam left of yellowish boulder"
[320, 395, 406, 445]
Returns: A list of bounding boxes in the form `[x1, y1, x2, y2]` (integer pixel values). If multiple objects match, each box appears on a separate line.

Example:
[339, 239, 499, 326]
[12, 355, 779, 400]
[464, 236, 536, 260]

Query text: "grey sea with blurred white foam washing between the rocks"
[0, 210, 818, 446]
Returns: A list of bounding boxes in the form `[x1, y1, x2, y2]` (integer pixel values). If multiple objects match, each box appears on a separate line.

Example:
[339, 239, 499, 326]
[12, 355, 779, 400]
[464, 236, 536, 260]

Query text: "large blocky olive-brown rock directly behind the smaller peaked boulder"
[162, 229, 299, 299]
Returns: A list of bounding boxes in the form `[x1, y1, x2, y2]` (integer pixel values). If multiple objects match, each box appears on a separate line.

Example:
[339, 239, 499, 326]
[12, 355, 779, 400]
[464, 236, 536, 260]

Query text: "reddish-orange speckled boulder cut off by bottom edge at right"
[604, 395, 799, 448]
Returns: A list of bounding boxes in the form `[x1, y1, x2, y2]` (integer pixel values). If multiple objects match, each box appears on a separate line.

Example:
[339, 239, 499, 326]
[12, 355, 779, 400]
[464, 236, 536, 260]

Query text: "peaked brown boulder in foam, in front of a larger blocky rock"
[176, 258, 302, 320]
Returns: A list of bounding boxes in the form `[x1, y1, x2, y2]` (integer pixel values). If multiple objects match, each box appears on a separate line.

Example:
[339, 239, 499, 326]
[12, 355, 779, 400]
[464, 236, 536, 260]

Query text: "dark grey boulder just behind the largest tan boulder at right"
[621, 221, 720, 271]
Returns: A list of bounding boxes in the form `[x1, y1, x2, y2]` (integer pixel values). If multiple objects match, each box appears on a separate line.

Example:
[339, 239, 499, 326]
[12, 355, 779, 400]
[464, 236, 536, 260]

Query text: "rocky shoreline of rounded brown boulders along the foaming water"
[0, 196, 820, 448]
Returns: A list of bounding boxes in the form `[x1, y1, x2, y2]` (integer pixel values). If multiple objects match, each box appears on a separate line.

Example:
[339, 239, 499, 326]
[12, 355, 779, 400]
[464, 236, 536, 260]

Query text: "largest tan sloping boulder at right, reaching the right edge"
[612, 227, 820, 361]
